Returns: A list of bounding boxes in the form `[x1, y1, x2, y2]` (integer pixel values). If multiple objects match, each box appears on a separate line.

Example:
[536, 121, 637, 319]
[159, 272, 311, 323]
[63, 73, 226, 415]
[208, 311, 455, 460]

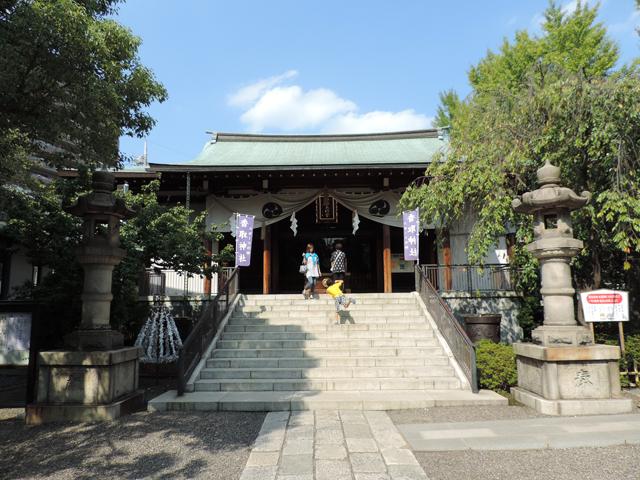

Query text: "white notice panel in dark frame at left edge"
[0, 312, 31, 365]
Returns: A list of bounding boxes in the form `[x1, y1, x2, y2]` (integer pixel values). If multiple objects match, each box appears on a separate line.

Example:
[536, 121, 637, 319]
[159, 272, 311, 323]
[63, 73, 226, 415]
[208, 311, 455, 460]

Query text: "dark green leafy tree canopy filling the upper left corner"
[0, 0, 167, 183]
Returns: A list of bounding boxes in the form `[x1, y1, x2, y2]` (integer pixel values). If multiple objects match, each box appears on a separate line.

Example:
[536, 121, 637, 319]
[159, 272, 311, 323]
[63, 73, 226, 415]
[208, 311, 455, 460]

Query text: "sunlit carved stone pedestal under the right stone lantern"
[511, 343, 633, 415]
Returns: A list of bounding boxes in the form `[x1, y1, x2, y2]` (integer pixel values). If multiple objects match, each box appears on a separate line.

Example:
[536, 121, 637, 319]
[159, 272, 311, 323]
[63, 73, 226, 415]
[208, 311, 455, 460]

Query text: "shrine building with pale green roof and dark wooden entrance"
[118, 129, 506, 293]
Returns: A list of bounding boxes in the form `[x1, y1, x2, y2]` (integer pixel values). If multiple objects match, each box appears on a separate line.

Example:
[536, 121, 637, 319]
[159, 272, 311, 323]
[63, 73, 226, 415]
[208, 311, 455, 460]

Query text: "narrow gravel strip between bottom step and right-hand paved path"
[387, 405, 544, 425]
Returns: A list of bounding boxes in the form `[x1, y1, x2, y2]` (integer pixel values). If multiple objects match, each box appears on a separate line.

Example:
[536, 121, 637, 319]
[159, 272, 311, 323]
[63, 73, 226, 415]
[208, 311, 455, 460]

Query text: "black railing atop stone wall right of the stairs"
[420, 263, 519, 294]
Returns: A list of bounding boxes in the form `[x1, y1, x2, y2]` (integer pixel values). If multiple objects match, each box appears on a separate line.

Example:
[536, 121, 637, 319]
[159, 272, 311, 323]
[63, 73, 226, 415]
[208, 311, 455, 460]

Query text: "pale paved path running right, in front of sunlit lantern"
[399, 414, 640, 452]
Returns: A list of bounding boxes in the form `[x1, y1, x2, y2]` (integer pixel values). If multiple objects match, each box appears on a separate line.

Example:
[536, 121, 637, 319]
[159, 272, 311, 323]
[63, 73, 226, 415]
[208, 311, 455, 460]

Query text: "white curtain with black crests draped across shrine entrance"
[207, 189, 410, 232]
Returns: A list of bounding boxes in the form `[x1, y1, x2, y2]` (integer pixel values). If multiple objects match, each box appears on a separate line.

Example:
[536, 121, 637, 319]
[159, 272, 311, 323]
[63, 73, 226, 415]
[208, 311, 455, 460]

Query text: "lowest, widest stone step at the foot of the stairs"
[148, 390, 508, 412]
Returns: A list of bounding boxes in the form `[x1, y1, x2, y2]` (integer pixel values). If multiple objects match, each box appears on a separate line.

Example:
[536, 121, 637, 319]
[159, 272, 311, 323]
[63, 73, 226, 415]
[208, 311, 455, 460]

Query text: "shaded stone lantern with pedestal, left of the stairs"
[26, 171, 142, 424]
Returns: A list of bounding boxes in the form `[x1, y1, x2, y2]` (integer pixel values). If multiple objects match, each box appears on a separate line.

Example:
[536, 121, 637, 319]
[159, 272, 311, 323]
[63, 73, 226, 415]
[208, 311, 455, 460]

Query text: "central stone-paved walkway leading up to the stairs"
[240, 410, 427, 480]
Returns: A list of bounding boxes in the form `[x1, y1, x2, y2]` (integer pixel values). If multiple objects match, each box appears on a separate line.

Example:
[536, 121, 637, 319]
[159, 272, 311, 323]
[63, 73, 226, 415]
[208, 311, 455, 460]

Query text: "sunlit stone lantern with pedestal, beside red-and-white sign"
[512, 162, 632, 415]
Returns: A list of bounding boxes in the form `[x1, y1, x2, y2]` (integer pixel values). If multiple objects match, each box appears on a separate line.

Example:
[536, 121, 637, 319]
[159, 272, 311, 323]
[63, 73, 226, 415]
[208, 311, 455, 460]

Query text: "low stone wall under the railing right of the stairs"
[441, 292, 523, 343]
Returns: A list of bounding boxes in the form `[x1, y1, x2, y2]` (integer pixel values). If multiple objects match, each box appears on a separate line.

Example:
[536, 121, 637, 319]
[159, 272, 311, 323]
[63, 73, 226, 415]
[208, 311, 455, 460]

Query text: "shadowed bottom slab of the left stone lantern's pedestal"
[25, 390, 144, 425]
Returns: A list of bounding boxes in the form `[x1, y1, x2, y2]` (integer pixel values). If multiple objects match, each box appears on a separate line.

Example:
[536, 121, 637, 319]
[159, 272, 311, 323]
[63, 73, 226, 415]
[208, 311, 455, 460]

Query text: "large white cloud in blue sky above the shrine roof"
[228, 70, 432, 133]
